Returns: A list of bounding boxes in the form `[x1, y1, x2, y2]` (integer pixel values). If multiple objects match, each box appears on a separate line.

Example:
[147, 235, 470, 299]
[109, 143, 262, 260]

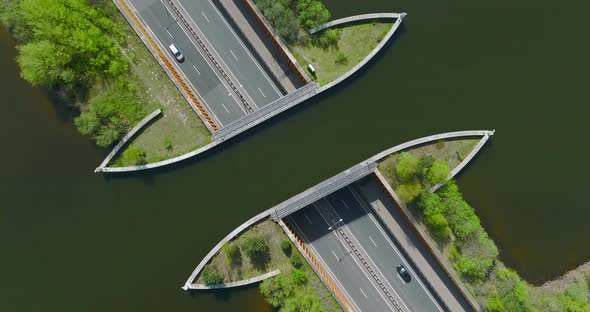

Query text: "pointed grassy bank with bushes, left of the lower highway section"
[195, 219, 342, 312]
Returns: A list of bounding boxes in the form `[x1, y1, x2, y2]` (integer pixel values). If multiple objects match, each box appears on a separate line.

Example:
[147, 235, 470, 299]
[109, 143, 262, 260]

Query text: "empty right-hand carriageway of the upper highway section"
[174, 0, 282, 108]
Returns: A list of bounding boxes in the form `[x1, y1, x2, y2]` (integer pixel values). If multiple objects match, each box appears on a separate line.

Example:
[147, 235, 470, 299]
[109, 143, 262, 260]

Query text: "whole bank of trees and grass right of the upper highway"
[254, 0, 394, 86]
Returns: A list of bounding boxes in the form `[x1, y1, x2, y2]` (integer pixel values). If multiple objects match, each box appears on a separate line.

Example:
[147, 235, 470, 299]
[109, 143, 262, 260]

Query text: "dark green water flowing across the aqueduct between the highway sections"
[0, 0, 590, 311]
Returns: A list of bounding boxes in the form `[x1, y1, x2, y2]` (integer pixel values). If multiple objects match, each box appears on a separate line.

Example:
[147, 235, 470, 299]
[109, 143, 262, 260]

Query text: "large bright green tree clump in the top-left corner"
[17, 0, 127, 85]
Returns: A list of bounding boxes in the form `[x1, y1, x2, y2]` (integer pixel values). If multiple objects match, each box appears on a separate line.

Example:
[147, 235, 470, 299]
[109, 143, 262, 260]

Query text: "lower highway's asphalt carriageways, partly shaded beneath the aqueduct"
[287, 187, 442, 311]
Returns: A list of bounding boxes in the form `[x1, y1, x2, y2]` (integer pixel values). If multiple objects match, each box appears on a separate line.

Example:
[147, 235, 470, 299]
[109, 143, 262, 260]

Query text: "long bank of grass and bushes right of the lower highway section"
[379, 139, 590, 312]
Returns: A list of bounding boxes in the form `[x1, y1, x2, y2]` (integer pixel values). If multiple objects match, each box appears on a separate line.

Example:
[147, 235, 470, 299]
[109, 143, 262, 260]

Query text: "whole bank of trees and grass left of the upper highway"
[0, 0, 211, 166]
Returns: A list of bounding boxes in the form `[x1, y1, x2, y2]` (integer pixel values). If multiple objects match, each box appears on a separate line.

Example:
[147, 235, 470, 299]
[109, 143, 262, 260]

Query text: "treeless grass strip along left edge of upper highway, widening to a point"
[103, 0, 211, 166]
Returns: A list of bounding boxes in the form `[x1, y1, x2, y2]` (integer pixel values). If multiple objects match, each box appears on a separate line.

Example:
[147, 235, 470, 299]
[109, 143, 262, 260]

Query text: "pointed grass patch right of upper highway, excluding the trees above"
[289, 22, 393, 85]
